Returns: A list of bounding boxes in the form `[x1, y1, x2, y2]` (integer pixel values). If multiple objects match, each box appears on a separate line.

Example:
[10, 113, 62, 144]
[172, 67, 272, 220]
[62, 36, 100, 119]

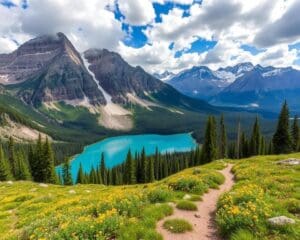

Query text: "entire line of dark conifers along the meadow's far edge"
[0, 102, 300, 185]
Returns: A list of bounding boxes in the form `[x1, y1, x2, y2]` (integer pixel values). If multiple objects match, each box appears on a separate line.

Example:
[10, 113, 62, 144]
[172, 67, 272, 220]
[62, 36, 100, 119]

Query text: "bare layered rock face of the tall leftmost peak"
[0, 33, 105, 105]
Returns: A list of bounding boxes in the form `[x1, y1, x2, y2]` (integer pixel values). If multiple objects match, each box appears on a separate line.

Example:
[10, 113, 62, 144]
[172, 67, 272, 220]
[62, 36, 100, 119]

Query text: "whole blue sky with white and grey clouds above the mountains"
[0, 0, 300, 72]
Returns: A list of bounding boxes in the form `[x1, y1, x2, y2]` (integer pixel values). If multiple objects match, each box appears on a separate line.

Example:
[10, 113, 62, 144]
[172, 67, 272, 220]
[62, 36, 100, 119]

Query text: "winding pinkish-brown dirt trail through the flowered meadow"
[157, 164, 234, 240]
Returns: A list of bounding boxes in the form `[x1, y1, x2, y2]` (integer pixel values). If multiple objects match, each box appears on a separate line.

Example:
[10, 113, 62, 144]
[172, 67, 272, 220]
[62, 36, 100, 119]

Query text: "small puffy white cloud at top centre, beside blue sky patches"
[118, 0, 155, 26]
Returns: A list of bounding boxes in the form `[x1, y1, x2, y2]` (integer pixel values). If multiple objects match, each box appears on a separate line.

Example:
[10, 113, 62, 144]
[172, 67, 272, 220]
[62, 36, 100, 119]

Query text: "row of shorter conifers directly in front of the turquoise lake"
[61, 147, 202, 185]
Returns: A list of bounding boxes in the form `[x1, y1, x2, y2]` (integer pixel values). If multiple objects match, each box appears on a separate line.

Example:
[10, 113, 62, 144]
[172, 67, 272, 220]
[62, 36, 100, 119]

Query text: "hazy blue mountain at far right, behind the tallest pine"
[211, 65, 300, 112]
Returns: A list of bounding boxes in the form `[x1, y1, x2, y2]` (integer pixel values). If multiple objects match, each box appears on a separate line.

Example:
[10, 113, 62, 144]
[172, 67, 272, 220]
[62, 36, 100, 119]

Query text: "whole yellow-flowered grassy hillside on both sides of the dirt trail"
[0, 154, 300, 240]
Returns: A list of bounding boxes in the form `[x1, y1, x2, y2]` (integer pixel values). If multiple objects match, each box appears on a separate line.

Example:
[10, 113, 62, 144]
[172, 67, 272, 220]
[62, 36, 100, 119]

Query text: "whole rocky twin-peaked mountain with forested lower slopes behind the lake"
[0, 33, 219, 142]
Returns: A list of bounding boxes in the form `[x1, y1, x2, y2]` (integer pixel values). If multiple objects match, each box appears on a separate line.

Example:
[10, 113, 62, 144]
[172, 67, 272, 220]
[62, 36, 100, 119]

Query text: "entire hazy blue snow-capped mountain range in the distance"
[162, 62, 300, 112]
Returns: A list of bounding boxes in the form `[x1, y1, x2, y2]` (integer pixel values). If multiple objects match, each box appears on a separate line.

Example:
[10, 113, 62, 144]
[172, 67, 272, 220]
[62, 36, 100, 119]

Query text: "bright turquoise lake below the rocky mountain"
[56, 133, 197, 181]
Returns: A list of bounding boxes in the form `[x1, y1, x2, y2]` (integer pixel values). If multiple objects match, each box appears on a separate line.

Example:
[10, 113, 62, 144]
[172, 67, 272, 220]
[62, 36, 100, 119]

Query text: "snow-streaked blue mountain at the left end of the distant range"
[168, 63, 253, 100]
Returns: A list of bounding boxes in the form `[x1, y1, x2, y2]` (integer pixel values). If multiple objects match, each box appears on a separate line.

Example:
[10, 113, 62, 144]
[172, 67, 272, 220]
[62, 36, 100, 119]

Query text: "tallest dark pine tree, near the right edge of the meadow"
[273, 101, 292, 154]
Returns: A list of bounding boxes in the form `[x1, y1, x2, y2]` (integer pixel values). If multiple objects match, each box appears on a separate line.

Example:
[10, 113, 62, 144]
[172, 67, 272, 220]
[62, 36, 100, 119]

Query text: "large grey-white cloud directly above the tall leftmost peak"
[0, 0, 124, 51]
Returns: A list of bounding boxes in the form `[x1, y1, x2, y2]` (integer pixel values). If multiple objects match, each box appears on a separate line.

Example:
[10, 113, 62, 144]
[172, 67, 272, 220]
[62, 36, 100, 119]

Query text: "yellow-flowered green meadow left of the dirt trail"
[0, 161, 224, 240]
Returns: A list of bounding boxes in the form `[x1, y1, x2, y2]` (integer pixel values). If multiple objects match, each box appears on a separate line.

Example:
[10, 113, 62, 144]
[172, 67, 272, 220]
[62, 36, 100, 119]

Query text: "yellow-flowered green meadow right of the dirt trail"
[217, 154, 300, 240]
